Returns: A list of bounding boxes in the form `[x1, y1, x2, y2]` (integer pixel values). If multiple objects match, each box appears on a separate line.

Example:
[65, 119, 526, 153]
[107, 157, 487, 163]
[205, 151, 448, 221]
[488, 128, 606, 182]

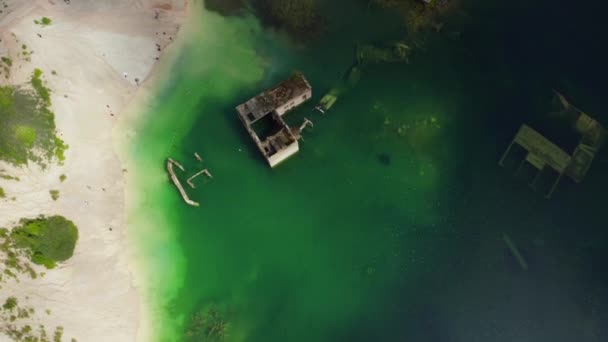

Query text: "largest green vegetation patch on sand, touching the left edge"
[0, 69, 68, 167]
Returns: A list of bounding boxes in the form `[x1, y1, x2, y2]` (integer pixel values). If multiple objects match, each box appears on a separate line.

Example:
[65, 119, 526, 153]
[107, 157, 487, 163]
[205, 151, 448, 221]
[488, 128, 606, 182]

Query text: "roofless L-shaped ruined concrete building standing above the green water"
[236, 72, 312, 167]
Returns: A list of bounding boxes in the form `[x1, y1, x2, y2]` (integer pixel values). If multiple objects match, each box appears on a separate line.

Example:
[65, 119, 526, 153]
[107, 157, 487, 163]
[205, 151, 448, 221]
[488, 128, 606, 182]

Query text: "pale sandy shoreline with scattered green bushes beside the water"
[0, 0, 188, 341]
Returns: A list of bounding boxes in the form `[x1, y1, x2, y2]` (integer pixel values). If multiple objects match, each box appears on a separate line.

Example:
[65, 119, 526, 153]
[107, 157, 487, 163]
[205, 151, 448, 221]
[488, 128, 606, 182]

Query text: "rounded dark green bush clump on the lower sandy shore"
[11, 216, 78, 268]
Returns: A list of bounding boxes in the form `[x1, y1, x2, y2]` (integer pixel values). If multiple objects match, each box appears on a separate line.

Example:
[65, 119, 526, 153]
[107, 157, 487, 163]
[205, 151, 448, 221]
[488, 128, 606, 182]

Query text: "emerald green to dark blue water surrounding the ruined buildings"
[133, 1, 608, 341]
